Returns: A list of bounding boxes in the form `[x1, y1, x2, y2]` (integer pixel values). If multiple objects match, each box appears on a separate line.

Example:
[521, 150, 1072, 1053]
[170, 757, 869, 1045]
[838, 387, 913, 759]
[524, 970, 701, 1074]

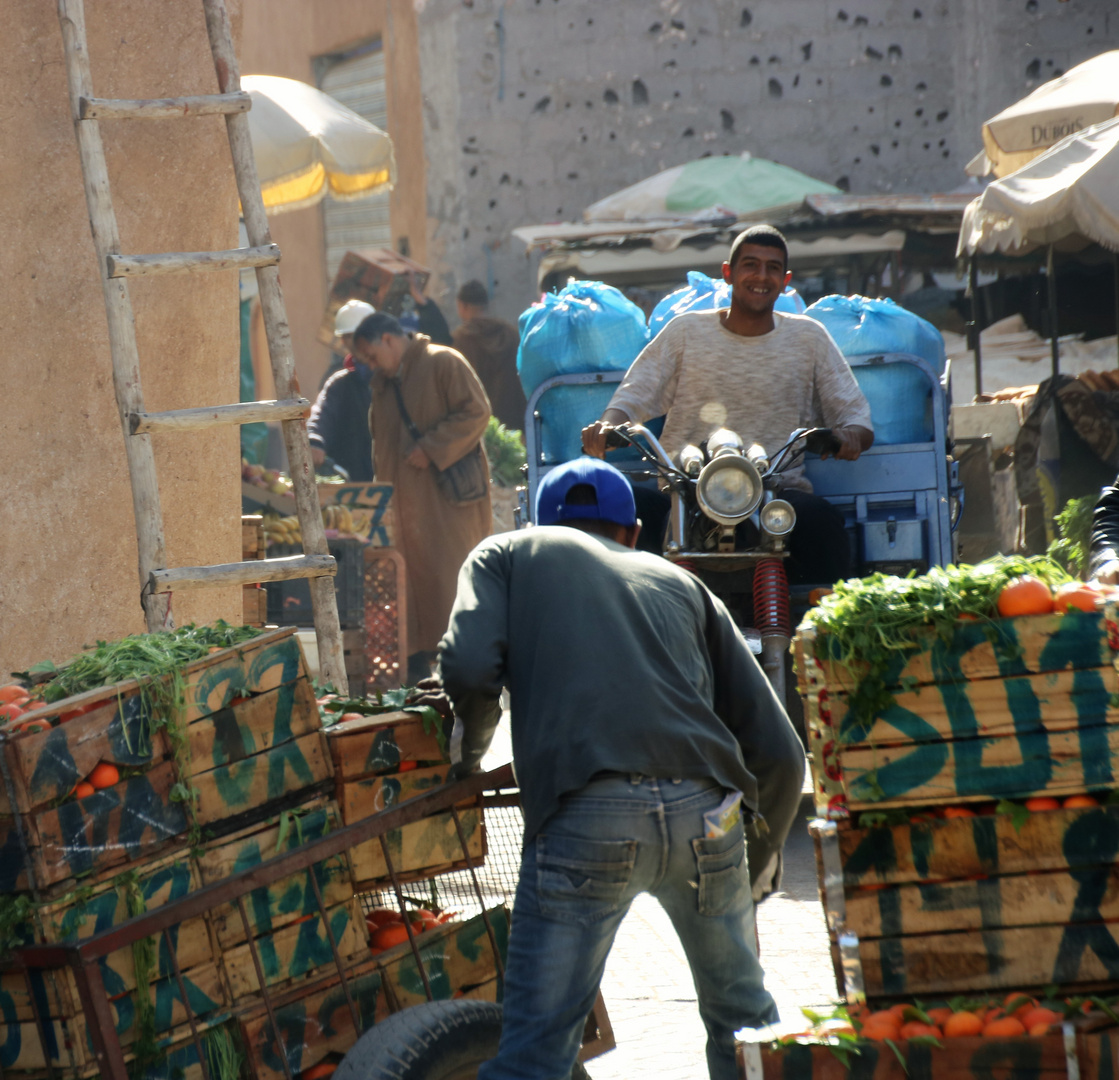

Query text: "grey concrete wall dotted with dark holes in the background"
[419, 0, 1119, 319]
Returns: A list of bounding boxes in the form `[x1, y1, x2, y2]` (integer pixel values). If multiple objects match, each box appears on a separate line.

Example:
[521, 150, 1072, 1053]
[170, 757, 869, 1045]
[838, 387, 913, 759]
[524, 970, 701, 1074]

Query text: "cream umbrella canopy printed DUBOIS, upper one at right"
[984, 49, 1119, 177]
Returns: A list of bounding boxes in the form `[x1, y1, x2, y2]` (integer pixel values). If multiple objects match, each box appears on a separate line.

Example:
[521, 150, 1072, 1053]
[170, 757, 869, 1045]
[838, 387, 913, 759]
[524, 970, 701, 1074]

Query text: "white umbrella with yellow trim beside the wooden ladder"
[241, 75, 396, 214]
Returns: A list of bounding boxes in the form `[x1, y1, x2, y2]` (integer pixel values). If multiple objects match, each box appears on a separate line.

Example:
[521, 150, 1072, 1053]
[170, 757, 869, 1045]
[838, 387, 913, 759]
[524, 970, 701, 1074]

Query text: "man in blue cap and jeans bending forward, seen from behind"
[440, 458, 805, 1080]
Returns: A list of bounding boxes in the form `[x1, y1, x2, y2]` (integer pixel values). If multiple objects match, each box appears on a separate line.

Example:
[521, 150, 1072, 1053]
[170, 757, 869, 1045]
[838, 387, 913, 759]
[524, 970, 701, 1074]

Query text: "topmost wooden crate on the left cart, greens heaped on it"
[0, 629, 332, 892]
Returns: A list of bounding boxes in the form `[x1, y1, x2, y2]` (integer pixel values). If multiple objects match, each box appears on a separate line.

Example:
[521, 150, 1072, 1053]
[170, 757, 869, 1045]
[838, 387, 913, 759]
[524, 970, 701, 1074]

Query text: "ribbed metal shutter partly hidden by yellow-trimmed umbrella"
[321, 41, 393, 281]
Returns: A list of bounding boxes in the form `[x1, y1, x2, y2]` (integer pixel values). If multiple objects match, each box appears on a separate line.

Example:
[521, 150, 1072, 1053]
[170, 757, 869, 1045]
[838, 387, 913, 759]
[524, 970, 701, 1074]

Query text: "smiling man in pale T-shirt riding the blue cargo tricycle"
[583, 225, 874, 583]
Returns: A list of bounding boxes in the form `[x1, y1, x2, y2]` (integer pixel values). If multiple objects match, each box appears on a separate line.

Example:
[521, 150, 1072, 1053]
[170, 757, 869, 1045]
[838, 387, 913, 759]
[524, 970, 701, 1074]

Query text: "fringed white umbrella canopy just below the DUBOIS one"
[957, 116, 1119, 255]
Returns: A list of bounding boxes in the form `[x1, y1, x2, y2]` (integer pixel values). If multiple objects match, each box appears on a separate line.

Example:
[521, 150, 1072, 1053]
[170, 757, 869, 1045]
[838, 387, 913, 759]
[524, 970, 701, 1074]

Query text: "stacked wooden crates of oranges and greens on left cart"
[0, 623, 499, 1080]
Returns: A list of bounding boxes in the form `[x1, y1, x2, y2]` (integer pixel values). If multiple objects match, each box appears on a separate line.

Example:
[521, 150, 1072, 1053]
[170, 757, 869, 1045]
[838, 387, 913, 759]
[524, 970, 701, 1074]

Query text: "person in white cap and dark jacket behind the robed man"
[307, 300, 374, 483]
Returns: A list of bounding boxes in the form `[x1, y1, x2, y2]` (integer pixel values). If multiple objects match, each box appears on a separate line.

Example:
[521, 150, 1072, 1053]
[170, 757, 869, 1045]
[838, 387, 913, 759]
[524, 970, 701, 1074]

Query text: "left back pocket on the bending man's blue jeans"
[536, 834, 637, 923]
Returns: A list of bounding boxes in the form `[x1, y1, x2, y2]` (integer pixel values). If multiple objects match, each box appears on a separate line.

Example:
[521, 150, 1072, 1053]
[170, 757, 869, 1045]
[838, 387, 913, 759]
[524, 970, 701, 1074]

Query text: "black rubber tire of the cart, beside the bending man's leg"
[331, 1001, 590, 1080]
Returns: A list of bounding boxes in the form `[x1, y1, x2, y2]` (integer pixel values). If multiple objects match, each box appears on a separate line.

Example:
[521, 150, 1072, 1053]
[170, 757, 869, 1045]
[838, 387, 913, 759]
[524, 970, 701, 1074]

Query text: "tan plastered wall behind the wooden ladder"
[0, 0, 241, 677]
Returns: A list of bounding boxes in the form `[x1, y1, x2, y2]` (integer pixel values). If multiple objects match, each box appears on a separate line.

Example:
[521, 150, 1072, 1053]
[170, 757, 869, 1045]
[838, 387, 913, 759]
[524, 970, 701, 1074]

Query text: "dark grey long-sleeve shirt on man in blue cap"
[440, 526, 805, 890]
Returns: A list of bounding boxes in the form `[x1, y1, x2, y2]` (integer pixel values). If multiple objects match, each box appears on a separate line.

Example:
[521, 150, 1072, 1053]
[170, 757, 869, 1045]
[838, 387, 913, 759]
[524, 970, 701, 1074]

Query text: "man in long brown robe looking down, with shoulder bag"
[354, 311, 493, 685]
